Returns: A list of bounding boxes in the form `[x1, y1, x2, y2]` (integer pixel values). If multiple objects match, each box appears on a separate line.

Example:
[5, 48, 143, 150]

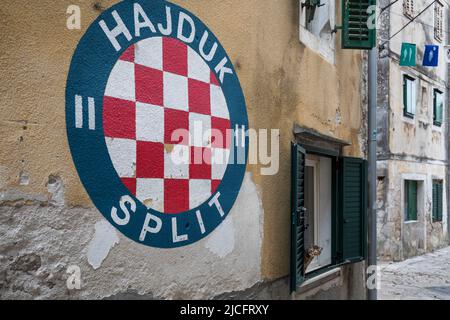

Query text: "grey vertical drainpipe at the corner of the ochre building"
[367, 47, 379, 300]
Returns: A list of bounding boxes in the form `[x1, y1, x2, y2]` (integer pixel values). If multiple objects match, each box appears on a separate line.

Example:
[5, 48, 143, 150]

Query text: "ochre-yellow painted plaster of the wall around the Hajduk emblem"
[0, 0, 365, 296]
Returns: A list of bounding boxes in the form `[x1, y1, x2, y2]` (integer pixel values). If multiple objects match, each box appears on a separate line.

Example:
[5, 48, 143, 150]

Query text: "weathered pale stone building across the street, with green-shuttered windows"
[377, 0, 448, 260]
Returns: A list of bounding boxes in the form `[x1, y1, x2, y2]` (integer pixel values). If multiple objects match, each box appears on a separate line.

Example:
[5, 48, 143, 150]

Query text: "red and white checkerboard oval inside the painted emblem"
[103, 37, 231, 214]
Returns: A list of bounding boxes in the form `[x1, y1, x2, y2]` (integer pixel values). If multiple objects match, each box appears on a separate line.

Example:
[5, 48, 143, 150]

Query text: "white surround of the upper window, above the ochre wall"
[299, 0, 336, 64]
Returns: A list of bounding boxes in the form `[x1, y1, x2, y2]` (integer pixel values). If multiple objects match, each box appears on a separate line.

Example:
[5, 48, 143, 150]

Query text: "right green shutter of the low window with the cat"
[339, 158, 368, 263]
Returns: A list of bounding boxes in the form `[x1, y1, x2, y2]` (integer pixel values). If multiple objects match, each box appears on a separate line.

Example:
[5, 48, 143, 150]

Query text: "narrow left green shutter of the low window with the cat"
[291, 144, 306, 292]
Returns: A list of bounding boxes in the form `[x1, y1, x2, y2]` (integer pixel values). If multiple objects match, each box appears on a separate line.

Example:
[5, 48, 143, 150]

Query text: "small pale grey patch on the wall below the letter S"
[87, 220, 119, 270]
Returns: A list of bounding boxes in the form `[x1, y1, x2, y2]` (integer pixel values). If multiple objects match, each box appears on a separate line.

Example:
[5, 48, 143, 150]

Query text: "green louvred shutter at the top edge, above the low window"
[342, 0, 376, 49]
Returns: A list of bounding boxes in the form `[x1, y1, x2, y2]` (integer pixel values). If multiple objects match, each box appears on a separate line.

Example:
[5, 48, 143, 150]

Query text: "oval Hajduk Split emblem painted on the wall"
[66, 0, 248, 248]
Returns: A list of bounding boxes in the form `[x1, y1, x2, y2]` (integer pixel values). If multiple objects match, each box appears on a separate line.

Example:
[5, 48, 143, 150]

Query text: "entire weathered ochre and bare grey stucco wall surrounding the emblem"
[0, 0, 366, 298]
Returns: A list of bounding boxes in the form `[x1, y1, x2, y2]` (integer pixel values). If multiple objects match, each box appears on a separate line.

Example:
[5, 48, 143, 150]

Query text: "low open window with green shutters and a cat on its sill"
[291, 144, 367, 291]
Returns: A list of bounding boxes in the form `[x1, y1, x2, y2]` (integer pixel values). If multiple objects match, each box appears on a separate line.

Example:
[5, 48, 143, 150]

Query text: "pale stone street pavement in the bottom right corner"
[378, 247, 450, 300]
